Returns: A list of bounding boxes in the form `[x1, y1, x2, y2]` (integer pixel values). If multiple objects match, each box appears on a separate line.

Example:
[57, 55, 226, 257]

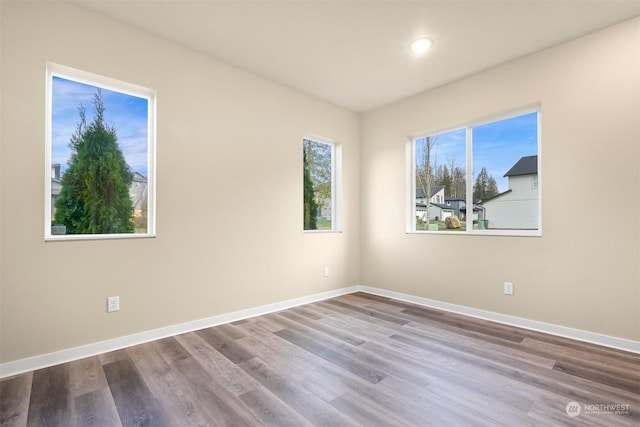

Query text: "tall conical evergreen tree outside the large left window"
[54, 90, 134, 234]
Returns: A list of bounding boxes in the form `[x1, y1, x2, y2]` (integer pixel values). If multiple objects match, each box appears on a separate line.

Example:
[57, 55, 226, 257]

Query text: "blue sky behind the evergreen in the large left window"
[51, 76, 148, 176]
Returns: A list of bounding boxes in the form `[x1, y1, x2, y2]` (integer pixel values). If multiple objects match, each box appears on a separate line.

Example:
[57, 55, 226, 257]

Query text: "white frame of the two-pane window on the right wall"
[405, 104, 542, 237]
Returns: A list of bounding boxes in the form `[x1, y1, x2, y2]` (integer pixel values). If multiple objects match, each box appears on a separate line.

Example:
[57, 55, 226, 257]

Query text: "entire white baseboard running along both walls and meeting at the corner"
[0, 286, 640, 378]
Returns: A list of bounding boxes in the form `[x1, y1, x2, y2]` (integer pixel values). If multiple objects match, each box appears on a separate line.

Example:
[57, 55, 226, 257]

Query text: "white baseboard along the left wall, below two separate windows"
[0, 286, 358, 378]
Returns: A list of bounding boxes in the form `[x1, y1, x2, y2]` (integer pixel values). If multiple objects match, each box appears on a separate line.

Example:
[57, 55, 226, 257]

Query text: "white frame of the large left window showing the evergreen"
[44, 63, 156, 241]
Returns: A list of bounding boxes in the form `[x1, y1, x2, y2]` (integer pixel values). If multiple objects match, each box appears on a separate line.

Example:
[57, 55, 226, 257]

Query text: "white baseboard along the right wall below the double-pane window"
[358, 286, 640, 354]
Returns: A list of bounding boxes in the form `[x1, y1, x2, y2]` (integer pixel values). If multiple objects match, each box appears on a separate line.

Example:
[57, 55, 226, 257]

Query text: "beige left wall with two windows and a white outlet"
[0, 2, 360, 362]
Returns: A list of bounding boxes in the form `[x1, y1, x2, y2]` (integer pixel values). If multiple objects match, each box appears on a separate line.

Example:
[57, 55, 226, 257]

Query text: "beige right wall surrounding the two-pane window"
[360, 19, 640, 340]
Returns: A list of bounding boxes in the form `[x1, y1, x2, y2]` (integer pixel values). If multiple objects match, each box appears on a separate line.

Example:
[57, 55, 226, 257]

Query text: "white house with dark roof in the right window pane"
[482, 156, 538, 230]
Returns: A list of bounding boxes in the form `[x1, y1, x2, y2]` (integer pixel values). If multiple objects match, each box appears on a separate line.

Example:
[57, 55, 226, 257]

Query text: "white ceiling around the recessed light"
[75, 0, 640, 112]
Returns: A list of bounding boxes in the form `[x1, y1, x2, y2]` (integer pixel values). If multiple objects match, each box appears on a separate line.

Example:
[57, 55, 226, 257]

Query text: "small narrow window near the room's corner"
[303, 138, 341, 231]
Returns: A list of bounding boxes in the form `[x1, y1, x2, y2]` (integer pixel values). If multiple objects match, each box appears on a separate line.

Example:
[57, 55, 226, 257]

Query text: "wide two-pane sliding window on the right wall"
[408, 108, 541, 235]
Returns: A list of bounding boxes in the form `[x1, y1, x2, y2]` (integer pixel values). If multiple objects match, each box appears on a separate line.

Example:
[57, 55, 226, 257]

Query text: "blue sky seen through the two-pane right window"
[416, 113, 538, 192]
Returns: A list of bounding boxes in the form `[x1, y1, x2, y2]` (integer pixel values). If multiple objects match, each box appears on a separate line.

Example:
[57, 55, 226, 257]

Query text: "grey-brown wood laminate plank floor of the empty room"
[0, 293, 640, 427]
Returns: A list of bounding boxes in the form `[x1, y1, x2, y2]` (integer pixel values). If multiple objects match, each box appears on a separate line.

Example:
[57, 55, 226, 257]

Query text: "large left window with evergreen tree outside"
[45, 64, 155, 240]
